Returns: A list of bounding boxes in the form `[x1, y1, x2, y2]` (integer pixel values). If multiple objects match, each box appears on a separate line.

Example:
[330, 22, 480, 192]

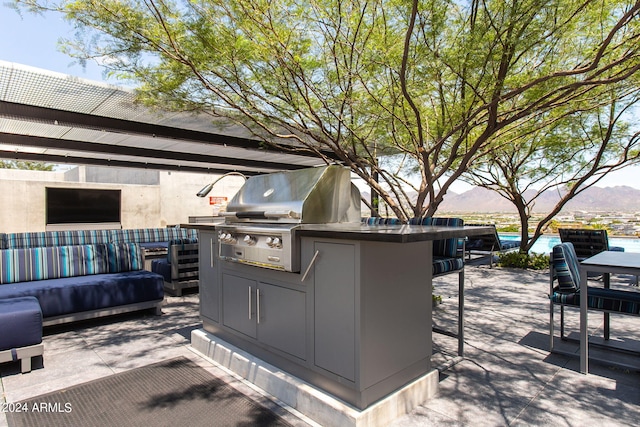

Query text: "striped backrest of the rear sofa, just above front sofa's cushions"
[6, 230, 112, 249]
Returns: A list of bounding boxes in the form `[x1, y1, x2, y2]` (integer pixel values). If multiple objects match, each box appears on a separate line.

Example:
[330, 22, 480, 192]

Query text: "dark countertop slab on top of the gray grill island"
[181, 223, 493, 243]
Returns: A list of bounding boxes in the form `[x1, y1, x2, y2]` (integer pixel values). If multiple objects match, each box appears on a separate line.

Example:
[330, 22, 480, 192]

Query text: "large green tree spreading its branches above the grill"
[14, 0, 640, 219]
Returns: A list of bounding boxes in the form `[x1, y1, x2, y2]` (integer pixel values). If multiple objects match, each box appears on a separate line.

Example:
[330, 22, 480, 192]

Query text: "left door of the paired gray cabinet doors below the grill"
[222, 274, 258, 338]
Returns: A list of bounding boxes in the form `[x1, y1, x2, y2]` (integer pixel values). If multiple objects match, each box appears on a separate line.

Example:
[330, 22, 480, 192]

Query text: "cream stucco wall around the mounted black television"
[0, 169, 244, 233]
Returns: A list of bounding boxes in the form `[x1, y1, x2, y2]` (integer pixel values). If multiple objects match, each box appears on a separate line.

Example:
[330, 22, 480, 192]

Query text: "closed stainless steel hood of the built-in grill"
[224, 165, 360, 224]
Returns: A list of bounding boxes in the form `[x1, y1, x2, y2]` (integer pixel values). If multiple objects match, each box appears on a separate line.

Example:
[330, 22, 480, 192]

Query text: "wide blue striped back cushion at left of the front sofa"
[0, 245, 109, 284]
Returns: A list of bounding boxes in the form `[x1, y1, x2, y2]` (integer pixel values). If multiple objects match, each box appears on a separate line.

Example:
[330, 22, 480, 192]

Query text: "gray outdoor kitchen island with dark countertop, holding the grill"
[189, 223, 487, 410]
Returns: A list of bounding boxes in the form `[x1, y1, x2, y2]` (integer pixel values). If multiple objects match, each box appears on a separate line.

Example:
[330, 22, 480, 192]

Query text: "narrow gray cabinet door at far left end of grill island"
[198, 231, 220, 322]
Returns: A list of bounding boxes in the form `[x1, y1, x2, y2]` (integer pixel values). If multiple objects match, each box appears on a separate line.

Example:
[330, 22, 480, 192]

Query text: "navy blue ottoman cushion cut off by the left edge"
[0, 297, 42, 351]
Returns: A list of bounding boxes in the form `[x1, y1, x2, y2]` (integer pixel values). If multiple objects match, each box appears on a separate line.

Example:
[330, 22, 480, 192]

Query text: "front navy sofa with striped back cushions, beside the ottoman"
[0, 243, 164, 328]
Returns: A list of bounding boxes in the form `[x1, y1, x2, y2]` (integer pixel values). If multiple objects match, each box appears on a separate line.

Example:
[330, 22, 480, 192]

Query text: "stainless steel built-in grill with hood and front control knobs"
[216, 166, 360, 272]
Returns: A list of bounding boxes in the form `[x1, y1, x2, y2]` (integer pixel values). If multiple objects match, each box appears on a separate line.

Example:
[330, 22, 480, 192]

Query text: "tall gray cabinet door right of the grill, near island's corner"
[314, 242, 356, 381]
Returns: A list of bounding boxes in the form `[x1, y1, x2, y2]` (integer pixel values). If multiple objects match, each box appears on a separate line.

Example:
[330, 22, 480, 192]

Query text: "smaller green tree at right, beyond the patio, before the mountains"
[465, 87, 640, 252]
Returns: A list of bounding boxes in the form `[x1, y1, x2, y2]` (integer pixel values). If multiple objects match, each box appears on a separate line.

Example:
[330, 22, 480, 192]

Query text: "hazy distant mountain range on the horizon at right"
[362, 186, 640, 213]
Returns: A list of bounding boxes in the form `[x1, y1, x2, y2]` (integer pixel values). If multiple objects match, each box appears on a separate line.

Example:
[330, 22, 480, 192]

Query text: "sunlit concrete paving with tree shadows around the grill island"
[0, 265, 640, 427]
